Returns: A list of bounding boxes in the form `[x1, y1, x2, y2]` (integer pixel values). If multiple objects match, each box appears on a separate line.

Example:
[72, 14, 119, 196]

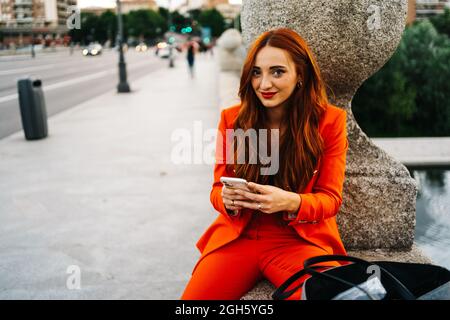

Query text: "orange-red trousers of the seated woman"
[181, 212, 339, 300]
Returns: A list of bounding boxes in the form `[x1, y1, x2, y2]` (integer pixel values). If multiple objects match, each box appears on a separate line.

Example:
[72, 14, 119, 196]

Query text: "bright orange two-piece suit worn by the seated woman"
[182, 105, 348, 299]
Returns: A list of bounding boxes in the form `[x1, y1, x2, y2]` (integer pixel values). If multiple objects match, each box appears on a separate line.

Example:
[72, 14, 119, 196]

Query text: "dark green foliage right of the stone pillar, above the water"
[352, 20, 450, 137]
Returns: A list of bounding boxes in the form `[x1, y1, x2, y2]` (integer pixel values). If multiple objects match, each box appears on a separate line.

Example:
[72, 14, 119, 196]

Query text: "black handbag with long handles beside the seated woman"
[272, 255, 450, 300]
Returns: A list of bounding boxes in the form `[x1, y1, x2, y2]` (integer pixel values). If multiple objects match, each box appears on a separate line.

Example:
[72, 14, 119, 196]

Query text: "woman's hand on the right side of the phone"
[230, 182, 301, 214]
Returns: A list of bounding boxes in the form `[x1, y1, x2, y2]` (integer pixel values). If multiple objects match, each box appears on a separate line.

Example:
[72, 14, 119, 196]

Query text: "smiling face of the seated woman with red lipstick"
[252, 46, 299, 108]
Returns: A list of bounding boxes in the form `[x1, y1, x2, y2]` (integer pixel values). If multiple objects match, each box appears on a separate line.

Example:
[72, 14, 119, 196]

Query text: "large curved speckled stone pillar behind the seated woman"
[241, 0, 417, 250]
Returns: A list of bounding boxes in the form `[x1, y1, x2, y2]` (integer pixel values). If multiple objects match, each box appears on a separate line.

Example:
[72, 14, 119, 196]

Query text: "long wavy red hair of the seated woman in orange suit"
[228, 28, 328, 192]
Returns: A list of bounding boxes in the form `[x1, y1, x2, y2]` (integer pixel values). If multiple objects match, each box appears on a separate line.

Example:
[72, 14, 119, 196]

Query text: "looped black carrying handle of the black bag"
[303, 255, 416, 300]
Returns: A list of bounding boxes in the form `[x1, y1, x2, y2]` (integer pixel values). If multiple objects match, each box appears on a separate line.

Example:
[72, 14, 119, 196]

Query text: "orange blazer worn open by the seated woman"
[192, 105, 348, 272]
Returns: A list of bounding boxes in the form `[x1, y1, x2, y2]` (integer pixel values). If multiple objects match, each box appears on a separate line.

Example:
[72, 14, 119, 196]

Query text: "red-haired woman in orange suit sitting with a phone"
[181, 28, 348, 300]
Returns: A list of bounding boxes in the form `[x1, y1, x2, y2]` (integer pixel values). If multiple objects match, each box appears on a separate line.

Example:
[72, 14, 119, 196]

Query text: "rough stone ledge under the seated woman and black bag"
[241, 245, 433, 300]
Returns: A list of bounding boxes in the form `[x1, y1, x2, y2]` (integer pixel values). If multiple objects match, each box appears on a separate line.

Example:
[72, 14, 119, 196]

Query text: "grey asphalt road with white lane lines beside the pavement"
[0, 48, 172, 138]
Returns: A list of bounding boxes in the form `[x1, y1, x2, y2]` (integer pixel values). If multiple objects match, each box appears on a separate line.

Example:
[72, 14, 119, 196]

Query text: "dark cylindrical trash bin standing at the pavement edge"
[17, 77, 48, 140]
